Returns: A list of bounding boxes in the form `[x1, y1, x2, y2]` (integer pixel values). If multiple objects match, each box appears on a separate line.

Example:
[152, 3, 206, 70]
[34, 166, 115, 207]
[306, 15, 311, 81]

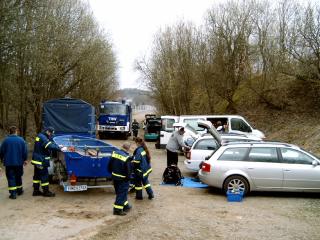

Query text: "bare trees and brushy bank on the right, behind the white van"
[136, 0, 320, 153]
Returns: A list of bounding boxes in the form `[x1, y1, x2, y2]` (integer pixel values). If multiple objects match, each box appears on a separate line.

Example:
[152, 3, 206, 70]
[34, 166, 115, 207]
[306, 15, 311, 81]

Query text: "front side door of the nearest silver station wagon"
[280, 148, 320, 190]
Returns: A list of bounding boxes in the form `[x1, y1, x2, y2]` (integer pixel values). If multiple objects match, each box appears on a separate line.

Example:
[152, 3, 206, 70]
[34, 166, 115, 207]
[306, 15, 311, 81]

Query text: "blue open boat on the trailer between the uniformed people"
[53, 135, 119, 178]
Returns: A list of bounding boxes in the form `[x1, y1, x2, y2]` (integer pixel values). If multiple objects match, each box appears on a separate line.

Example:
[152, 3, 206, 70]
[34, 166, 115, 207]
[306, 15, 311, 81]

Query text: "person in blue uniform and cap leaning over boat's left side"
[31, 127, 61, 197]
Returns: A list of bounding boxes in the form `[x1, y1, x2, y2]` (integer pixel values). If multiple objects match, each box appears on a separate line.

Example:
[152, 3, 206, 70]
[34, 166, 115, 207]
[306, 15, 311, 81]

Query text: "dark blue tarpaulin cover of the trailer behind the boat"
[42, 98, 95, 137]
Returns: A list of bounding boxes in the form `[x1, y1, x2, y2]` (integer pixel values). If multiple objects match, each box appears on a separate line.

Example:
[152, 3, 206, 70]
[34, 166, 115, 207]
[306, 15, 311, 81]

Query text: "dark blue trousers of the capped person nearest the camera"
[113, 180, 129, 210]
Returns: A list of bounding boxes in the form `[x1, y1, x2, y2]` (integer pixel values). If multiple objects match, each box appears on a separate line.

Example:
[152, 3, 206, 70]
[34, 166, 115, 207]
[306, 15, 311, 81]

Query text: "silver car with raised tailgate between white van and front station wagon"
[184, 134, 262, 172]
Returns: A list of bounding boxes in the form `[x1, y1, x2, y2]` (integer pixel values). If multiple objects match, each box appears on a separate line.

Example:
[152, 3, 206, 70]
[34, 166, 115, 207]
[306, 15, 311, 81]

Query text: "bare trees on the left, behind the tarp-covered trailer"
[0, 0, 118, 136]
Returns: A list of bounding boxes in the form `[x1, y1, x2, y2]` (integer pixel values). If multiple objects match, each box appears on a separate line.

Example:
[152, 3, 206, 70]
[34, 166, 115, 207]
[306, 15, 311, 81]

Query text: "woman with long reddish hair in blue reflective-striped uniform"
[132, 137, 154, 200]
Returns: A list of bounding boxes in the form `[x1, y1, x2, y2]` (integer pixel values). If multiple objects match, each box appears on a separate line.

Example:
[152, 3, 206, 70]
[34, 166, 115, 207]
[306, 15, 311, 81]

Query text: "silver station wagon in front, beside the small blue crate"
[199, 120, 320, 194]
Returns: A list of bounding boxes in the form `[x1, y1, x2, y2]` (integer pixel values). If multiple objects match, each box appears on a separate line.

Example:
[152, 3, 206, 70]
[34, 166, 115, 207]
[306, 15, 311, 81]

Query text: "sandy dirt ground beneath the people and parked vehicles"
[0, 132, 320, 240]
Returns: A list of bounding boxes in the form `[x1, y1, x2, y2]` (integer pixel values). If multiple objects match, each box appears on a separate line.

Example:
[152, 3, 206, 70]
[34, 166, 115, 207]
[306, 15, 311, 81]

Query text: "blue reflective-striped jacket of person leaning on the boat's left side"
[31, 133, 60, 167]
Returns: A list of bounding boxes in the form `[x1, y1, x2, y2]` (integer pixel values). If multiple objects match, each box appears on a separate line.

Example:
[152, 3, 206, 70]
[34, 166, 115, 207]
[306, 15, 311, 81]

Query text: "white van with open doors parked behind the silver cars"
[160, 115, 265, 148]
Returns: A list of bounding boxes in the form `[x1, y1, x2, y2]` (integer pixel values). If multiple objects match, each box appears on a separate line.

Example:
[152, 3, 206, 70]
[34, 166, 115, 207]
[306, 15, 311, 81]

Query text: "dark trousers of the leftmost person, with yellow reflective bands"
[6, 166, 23, 194]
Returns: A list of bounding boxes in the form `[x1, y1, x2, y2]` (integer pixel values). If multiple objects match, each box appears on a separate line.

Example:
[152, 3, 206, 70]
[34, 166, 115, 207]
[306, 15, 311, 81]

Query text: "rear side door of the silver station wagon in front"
[245, 147, 283, 189]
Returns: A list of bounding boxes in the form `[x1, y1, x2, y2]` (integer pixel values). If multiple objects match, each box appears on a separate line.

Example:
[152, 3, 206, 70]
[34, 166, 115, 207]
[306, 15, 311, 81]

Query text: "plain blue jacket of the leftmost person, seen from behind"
[0, 135, 28, 166]
